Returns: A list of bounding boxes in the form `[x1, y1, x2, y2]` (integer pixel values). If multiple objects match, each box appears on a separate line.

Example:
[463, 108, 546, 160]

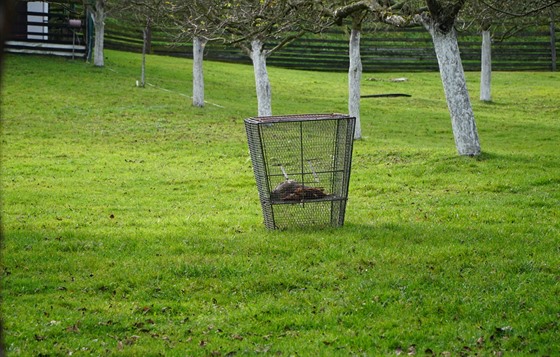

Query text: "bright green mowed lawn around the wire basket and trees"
[1, 51, 560, 356]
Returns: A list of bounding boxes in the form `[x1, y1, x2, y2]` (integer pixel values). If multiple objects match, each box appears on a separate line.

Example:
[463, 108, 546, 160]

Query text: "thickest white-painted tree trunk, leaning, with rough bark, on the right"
[427, 24, 480, 156]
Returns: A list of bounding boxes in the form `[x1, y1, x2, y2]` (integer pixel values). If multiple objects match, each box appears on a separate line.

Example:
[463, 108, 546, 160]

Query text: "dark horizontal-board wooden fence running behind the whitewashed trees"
[105, 22, 558, 72]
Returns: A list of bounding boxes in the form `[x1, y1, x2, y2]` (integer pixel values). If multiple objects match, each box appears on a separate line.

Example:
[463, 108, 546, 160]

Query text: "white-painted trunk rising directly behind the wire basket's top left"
[251, 40, 272, 116]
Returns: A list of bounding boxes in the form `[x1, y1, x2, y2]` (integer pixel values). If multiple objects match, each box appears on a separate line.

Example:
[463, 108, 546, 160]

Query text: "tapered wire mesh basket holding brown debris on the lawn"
[245, 114, 355, 229]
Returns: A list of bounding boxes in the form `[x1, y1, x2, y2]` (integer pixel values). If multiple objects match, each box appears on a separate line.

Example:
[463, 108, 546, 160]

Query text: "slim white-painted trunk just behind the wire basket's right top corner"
[348, 29, 362, 139]
